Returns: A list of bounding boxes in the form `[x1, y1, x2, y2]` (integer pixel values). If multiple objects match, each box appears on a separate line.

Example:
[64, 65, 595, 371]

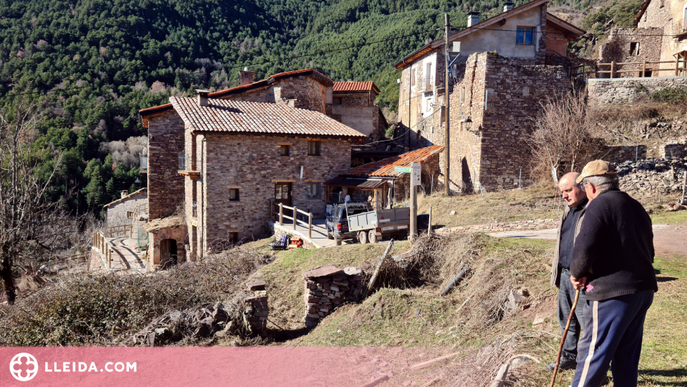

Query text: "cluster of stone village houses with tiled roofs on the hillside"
[91, 0, 687, 271]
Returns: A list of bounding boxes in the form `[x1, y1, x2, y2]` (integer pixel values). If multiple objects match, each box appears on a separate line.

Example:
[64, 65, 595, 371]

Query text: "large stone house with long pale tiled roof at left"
[142, 91, 366, 262]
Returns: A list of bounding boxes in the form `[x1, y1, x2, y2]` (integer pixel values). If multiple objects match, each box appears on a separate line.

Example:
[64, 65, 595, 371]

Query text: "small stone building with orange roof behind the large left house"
[331, 81, 388, 141]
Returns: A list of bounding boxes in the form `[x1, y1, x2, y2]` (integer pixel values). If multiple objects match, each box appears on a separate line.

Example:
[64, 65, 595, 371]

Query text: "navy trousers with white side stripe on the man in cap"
[572, 290, 654, 387]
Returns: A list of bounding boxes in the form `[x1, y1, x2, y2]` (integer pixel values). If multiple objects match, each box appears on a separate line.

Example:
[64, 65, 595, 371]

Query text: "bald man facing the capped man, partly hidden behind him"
[546, 172, 587, 371]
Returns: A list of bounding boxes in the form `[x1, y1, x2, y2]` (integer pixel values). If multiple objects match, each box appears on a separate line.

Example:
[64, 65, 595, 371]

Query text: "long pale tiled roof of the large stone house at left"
[169, 97, 366, 138]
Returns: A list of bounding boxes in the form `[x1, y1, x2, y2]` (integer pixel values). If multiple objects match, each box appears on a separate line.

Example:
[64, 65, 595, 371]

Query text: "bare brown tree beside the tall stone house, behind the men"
[527, 94, 604, 185]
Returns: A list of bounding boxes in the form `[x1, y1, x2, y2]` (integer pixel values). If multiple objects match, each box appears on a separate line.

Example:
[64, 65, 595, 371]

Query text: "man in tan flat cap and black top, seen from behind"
[570, 160, 658, 387]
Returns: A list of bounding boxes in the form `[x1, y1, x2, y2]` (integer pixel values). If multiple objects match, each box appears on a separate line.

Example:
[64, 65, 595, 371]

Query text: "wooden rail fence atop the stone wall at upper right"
[572, 57, 687, 78]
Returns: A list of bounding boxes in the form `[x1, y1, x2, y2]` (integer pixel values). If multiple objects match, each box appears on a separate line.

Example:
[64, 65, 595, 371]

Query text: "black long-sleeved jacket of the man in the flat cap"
[570, 190, 658, 301]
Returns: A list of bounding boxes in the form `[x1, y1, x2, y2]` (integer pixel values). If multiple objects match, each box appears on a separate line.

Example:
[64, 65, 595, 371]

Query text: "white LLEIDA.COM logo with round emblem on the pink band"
[10, 352, 137, 382]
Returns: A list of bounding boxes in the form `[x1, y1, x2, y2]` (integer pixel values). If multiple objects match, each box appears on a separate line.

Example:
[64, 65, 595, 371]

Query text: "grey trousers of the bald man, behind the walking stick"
[558, 269, 586, 359]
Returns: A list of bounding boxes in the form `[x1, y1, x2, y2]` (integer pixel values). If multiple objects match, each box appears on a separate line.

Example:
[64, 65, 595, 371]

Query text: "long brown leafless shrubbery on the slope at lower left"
[0, 248, 259, 346]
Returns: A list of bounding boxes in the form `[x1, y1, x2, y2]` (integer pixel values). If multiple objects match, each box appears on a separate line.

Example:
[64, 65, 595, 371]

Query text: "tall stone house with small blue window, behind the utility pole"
[396, 0, 584, 192]
